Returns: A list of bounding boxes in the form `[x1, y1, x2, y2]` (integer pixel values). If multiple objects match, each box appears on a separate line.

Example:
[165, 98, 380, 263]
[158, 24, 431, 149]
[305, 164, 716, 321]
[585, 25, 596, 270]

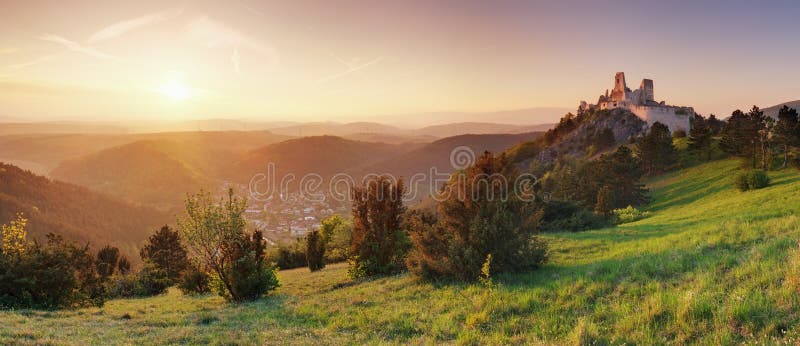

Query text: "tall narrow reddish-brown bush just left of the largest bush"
[350, 176, 408, 277]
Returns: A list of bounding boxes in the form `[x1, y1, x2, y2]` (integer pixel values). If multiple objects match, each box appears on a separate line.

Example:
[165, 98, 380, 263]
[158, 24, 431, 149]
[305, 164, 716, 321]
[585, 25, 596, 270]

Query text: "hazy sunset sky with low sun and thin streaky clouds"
[0, 0, 800, 124]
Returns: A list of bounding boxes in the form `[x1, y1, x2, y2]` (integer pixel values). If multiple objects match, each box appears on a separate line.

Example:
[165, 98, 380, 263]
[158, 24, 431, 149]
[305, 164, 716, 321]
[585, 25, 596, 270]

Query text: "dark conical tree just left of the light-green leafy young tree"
[139, 225, 189, 283]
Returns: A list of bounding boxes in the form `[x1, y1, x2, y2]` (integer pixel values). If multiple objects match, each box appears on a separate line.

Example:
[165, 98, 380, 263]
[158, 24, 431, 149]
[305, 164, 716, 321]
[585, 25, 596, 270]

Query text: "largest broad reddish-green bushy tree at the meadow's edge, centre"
[406, 152, 546, 281]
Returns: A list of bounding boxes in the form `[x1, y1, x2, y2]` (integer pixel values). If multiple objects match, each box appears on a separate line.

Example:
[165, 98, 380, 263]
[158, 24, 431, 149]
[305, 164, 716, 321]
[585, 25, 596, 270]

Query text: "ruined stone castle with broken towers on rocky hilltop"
[578, 72, 695, 131]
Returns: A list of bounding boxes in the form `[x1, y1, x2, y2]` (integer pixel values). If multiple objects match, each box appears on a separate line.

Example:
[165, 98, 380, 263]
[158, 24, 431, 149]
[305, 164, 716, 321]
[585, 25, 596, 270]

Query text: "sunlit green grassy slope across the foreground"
[0, 160, 800, 345]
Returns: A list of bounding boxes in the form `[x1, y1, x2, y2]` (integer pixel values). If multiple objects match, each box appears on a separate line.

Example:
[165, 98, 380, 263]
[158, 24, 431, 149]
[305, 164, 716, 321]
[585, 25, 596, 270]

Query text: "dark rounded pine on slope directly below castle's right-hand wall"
[635, 122, 678, 175]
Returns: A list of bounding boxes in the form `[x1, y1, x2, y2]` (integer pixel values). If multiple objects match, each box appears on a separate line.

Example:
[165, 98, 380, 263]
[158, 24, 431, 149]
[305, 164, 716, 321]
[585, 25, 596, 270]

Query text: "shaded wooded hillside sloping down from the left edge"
[0, 163, 169, 261]
